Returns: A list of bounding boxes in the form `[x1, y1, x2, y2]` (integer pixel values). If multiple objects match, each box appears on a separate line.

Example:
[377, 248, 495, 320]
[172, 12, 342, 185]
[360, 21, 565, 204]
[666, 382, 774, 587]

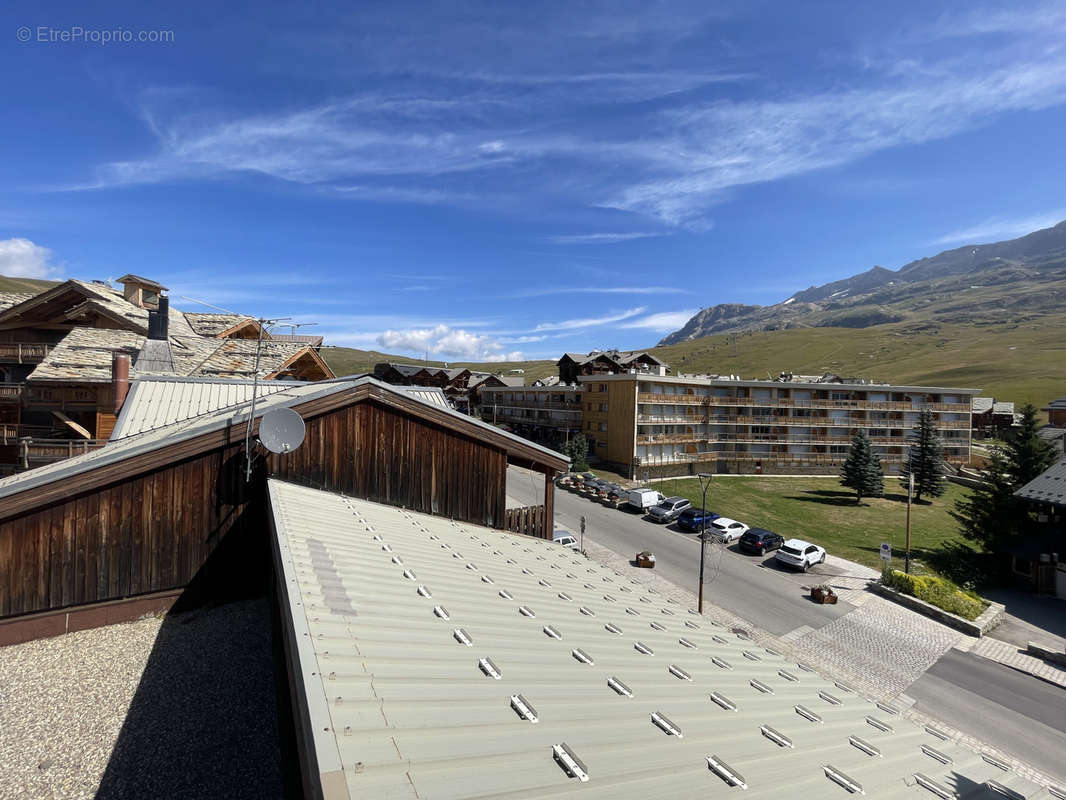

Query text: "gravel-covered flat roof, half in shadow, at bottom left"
[0, 598, 284, 799]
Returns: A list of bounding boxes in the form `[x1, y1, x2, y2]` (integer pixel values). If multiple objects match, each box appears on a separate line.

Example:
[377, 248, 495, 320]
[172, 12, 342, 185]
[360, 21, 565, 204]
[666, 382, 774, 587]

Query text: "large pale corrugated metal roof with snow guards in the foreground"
[270, 480, 1049, 800]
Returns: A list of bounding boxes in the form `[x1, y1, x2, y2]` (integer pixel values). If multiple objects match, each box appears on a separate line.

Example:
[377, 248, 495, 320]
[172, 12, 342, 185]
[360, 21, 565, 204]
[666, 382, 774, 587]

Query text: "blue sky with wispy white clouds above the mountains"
[0, 0, 1066, 361]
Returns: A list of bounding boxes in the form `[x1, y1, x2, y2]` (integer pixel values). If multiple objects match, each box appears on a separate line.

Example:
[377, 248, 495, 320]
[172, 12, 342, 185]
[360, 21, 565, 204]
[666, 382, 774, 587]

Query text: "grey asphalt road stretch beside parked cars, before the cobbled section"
[507, 470, 852, 636]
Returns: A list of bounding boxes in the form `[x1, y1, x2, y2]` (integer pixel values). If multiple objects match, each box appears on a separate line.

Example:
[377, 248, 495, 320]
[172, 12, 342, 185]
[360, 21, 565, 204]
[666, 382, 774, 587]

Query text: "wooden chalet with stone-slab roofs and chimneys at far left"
[0, 275, 334, 471]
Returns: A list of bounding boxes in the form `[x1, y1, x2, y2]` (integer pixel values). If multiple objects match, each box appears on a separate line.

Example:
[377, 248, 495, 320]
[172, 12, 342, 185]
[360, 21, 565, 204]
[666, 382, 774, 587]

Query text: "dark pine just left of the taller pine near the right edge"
[951, 448, 1025, 551]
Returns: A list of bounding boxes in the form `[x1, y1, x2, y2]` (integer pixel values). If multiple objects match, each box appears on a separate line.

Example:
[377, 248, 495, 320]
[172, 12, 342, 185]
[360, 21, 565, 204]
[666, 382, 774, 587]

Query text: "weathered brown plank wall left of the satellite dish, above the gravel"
[0, 444, 256, 618]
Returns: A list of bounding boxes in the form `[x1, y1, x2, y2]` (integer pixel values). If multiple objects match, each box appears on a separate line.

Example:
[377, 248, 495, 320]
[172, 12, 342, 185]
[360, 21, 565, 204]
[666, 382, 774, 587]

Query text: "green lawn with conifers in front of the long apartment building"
[649, 477, 969, 569]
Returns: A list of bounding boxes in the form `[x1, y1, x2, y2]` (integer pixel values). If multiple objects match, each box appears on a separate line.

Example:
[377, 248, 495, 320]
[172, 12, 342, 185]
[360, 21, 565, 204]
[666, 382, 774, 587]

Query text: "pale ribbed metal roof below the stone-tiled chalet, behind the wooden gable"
[111, 378, 304, 442]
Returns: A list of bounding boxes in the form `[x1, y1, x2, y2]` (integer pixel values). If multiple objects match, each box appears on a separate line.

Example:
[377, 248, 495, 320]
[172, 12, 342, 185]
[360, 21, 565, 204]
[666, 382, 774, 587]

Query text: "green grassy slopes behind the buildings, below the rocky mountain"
[323, 315, 1066, 407]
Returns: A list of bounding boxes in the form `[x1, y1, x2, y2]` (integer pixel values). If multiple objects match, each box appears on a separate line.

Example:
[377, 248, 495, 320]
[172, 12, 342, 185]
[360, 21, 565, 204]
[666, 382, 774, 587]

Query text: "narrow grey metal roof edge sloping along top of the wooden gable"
[0, 375, 566, 498]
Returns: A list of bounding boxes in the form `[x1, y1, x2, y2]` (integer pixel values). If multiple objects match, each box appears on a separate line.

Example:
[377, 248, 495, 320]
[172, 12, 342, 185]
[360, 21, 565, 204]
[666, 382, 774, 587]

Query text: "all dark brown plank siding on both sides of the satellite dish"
[0, 396, 520, 619]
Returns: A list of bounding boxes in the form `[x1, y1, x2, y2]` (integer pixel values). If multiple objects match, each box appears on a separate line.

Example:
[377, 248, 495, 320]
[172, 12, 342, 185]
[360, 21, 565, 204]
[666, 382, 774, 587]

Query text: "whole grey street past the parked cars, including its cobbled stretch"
[507, 467, 1066, 782]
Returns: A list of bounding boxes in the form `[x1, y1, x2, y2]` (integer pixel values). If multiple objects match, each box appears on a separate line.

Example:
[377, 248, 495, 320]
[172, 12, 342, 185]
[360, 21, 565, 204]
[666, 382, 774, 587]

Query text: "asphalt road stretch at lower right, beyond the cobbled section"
[907, 650, 1066, 784]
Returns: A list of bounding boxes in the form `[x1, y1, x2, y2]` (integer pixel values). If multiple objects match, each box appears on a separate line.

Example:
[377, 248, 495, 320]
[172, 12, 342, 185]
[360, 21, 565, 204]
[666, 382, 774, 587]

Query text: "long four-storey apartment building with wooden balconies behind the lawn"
[578, 373, 978, 478]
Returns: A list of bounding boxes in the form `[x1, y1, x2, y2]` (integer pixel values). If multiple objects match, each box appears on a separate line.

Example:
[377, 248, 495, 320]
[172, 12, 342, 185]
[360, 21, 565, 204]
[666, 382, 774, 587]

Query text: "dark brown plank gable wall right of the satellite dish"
[270, 401, 507, 528]
